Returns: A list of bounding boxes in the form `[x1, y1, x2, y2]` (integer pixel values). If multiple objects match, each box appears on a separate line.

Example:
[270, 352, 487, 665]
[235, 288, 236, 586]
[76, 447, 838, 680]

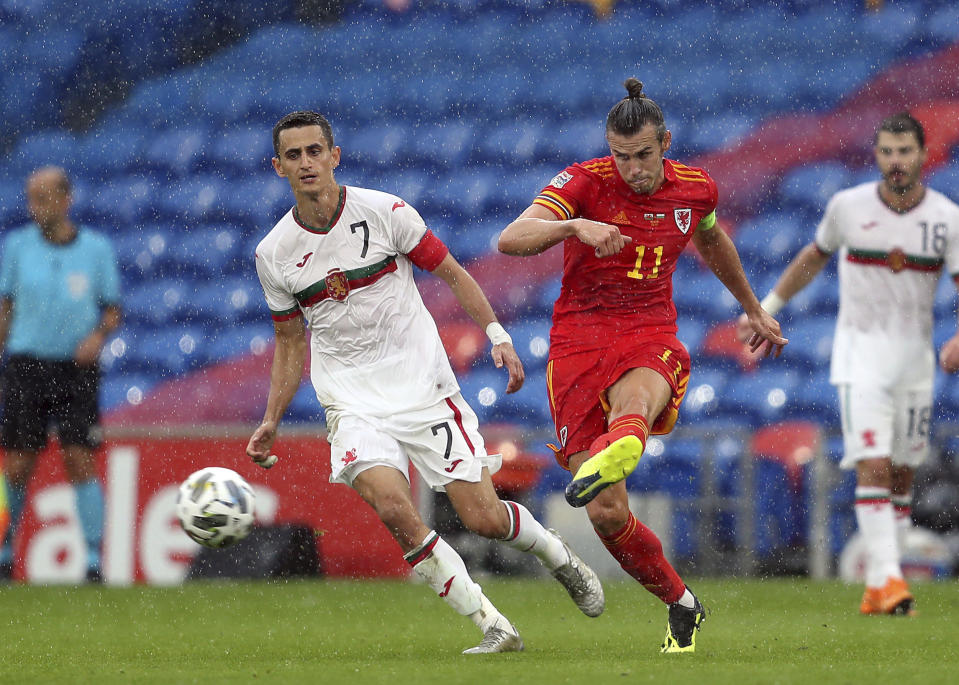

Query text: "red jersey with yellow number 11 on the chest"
[533, 157, 718, 358]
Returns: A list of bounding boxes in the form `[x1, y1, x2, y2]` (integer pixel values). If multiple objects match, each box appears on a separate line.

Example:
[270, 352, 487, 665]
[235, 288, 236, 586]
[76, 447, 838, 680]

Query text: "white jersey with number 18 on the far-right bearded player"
[816, 182, 959, 390]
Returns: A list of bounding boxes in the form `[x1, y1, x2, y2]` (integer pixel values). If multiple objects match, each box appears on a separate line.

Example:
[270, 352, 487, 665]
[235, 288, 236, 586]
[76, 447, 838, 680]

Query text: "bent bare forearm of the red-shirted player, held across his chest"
[497, 205, 632, 257]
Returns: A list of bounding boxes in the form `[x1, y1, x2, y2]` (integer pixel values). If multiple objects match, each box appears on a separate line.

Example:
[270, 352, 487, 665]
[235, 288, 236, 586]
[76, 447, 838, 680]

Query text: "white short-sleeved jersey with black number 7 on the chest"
[256, 186, 459, 430]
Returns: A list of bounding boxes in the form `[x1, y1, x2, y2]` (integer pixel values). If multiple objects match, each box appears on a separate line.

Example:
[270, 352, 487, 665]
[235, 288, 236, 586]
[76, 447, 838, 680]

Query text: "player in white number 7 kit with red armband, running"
[247, 112, 605, 654]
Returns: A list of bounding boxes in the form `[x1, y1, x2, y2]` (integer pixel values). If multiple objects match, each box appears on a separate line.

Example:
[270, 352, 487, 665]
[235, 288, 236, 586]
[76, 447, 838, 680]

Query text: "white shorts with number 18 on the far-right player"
[836, 383, 932, 469]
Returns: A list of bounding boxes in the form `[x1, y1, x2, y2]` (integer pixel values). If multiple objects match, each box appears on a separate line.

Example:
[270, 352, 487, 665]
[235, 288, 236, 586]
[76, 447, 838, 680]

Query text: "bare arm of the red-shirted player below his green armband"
[692, 226, 789, 357]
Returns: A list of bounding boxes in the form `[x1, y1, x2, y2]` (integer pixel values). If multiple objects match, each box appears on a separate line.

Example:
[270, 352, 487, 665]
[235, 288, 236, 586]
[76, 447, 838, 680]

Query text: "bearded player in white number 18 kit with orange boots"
[740, 112, 959, 614]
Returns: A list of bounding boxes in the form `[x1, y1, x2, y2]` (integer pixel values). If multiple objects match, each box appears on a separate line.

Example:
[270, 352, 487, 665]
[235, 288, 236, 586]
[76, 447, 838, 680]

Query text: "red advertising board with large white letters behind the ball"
[7, 435, 410, 584]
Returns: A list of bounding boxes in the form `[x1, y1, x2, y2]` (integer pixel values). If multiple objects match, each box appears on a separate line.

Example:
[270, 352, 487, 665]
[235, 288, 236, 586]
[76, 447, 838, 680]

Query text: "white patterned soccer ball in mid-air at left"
[176, 466, 255, 549]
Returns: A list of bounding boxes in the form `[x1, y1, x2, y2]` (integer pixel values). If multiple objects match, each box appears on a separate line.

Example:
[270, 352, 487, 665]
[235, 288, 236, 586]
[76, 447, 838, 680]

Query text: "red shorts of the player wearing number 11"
[546, 334, 689, 469]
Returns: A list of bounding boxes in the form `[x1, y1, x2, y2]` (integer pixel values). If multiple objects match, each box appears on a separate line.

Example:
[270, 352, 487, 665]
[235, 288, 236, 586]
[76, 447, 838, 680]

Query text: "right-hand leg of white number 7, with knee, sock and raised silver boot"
[446, 468, 606, 617]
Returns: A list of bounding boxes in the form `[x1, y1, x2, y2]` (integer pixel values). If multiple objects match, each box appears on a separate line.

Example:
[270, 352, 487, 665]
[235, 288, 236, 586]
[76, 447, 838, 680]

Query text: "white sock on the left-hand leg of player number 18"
[856, 487, 902, 587]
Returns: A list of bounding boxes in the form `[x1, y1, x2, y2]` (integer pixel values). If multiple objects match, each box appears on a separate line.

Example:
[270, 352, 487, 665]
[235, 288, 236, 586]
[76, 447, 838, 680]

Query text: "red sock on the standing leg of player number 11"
[597, 512, 686, 604]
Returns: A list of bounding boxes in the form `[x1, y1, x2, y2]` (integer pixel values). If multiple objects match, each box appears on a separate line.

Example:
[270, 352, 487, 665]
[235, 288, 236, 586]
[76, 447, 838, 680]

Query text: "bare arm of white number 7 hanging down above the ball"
[246, 316, 308, 462]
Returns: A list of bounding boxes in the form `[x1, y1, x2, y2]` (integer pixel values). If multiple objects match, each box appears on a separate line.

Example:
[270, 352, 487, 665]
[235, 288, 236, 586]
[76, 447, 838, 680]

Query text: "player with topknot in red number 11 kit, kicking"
[499, 78, 787, 652]
